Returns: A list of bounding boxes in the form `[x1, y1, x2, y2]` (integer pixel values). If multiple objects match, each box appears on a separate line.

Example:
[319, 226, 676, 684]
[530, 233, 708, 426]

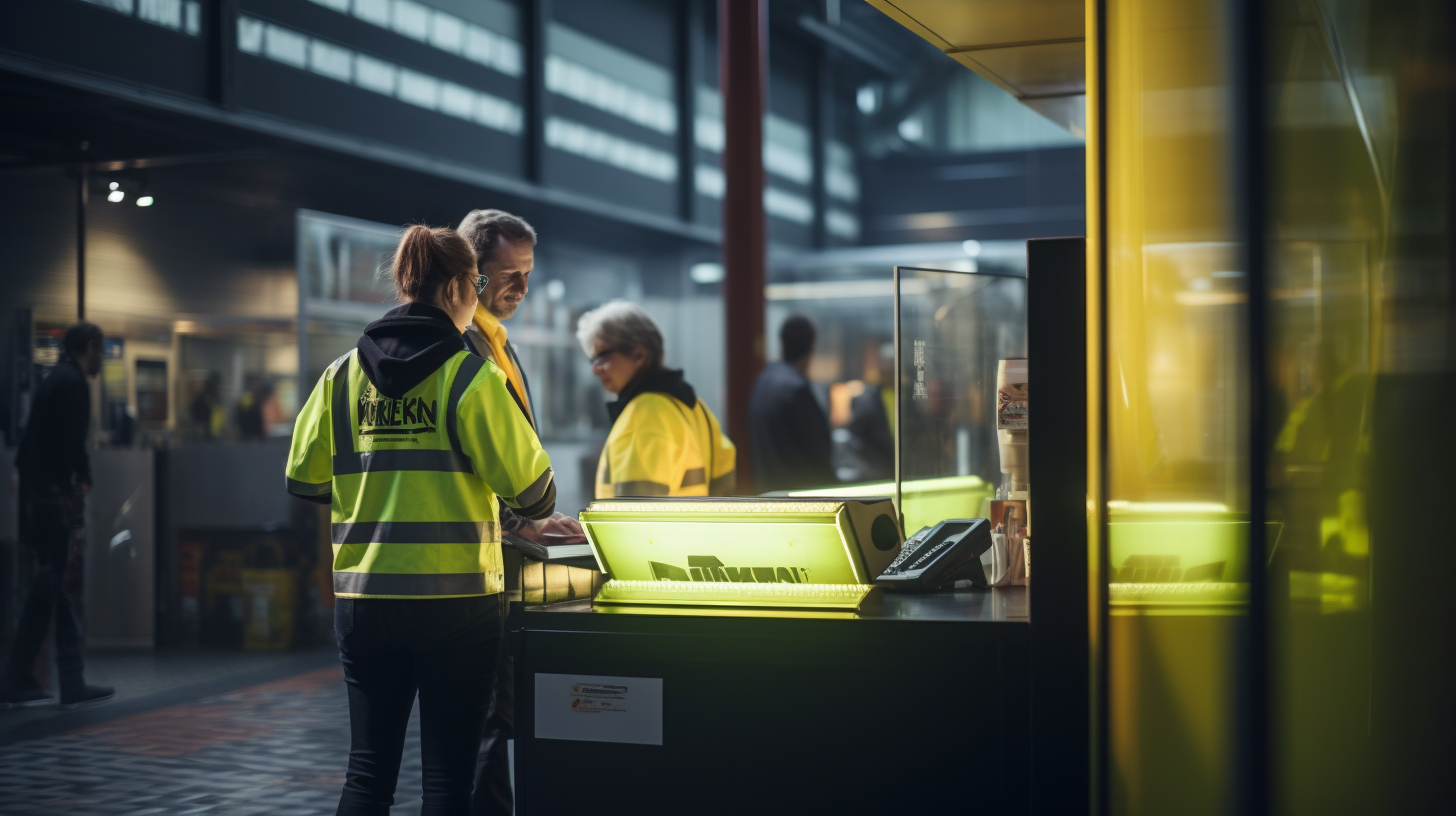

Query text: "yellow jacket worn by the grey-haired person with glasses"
[596, 391, 738, 498]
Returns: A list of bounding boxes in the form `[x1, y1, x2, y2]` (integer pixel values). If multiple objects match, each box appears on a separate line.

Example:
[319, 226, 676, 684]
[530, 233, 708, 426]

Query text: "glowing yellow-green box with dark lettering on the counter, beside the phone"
[581, 498, 903, 608]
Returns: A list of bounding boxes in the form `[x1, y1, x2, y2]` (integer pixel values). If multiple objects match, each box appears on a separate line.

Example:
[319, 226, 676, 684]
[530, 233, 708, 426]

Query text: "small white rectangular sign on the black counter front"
[536, 673, 662, 745]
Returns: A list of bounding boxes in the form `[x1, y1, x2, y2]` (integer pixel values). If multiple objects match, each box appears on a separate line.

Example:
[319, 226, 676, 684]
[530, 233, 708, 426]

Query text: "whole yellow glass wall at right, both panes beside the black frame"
[1089, 0, 1456, 816]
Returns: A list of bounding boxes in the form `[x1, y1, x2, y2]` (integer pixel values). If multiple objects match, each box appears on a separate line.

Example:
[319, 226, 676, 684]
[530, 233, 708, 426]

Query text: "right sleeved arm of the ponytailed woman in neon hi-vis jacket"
[456, 363, 556, 519]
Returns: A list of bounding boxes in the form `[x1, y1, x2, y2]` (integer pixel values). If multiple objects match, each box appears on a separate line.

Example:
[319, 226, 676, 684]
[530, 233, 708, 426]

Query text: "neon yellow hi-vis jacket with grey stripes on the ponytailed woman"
[287, 350, 555, 597]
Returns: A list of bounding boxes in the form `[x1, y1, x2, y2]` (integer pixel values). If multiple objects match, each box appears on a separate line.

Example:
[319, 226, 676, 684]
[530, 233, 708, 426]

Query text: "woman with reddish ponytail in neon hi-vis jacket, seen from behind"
[287, 226, 556, 816]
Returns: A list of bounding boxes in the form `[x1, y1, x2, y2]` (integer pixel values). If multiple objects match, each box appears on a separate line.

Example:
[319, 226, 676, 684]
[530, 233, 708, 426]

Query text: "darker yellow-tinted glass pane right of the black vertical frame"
[1267, 0, 1456, 815]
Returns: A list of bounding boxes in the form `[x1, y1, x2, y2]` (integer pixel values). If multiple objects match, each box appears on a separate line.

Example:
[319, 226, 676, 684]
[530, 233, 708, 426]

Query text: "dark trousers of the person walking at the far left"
[4, 484, 83, 688]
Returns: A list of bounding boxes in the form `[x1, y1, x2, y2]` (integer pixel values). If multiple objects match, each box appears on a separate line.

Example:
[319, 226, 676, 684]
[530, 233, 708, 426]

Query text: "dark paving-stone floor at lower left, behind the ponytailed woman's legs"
[0, 666, 421, 816]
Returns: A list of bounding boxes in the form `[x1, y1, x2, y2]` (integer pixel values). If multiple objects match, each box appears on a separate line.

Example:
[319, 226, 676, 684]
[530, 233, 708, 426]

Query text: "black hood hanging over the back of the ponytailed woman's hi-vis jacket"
[358, 303, 466, 399]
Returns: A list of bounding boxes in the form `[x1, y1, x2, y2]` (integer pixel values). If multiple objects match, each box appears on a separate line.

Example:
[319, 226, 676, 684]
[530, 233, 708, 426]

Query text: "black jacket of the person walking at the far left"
[15, 354, 90, 490]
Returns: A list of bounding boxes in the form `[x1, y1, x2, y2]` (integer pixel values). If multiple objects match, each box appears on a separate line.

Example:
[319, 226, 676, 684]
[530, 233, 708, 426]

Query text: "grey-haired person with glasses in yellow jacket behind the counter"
[577, 300, 738, 498]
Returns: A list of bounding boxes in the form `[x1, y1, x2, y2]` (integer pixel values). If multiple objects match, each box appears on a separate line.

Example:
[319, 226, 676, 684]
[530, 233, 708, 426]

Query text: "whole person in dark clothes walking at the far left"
[0, 323, 115, 707]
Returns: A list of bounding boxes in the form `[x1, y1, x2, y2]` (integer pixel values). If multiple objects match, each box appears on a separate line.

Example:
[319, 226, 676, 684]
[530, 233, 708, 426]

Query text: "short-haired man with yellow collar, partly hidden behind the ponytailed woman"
[459, 210, 585, 816]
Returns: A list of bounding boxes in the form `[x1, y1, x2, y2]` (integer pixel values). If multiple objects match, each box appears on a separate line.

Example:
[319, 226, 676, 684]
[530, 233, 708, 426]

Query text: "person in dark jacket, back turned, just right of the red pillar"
[748, 315, 836, 493]
